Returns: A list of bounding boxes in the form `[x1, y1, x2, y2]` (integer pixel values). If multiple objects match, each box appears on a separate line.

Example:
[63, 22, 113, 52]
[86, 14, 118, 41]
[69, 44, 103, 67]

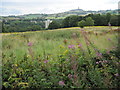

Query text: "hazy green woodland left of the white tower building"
[0, 19, 45, 33]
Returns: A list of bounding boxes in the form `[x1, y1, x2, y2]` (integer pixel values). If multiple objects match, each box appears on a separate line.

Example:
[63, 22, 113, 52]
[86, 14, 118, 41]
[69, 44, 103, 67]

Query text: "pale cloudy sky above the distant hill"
[0, 0, 120, 16]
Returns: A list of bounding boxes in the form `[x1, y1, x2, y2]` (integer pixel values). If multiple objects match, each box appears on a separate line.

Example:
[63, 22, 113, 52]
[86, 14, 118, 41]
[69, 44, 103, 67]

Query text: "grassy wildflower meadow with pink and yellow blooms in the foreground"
[2, 26, 120, 88]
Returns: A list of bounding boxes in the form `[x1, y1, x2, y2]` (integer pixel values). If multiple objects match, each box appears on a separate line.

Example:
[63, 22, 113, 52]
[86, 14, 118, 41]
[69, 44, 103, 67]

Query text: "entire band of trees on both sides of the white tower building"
[0, 13, 120, 33]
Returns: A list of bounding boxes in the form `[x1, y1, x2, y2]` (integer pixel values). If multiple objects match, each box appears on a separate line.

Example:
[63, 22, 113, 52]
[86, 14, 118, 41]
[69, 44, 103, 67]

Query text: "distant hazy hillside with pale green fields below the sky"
[3, 9, 118, 19]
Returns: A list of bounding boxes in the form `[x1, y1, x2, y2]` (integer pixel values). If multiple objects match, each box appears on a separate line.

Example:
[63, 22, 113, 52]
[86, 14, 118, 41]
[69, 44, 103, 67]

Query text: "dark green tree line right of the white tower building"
[48, 13, 120, 29]
